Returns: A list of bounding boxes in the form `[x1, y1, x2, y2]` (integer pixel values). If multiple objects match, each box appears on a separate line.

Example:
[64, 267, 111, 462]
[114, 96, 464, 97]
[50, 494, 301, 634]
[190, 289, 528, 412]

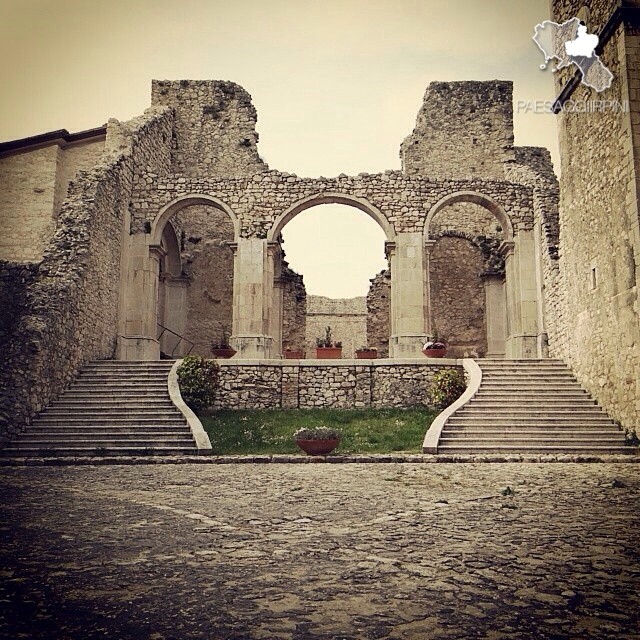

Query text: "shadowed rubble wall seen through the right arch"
[429, 237, 487, 358]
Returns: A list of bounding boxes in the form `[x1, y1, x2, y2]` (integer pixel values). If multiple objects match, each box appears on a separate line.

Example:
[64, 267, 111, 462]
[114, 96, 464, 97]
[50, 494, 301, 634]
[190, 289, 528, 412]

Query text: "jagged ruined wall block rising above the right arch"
[400, 80, 513, 180]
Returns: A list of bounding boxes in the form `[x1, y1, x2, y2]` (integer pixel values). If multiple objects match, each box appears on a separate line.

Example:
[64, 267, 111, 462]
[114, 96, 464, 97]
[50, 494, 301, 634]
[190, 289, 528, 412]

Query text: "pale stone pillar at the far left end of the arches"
[116, 233, 165, 360]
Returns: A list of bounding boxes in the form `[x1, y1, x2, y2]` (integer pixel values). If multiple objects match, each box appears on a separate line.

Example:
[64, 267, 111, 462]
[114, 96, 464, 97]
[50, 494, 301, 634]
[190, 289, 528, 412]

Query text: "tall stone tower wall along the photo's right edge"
[549, 0, 640, 433]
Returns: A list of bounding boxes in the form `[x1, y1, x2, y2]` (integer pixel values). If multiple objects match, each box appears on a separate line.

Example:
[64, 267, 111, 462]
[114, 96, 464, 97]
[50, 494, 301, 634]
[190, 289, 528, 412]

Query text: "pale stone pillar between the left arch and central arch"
[231, 238, 274, 360]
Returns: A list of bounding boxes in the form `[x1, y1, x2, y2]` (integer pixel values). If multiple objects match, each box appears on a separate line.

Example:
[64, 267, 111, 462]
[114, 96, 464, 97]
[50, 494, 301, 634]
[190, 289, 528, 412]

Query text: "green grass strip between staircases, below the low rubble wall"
[199, 408, 438, 454]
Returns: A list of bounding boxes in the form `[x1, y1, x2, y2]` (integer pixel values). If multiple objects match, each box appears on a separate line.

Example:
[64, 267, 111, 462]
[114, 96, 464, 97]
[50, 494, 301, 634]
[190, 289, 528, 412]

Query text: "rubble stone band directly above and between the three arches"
[132, 171, 534, 239]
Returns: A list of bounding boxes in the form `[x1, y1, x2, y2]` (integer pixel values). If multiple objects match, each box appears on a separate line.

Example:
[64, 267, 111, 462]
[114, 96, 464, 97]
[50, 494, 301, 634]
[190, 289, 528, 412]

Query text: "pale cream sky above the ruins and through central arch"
[0, 0, 558, 297]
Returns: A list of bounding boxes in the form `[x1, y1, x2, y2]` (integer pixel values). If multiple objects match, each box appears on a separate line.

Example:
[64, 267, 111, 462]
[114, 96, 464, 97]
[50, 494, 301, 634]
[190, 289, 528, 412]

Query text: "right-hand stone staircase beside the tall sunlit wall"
[437, 359, 636, 455]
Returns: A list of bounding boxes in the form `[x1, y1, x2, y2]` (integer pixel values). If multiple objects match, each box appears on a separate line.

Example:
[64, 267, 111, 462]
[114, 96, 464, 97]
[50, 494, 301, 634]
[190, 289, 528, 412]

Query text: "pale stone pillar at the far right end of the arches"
[502, 231, 540, 359]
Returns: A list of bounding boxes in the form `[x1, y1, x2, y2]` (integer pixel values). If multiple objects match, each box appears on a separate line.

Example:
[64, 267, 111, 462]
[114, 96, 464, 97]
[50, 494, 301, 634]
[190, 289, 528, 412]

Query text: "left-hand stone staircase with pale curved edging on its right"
[2, 360, 198, 456]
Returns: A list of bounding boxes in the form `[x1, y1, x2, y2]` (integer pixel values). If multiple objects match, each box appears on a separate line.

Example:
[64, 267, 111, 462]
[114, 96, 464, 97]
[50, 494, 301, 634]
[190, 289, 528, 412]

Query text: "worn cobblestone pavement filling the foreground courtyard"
[0, 463, 640, 640]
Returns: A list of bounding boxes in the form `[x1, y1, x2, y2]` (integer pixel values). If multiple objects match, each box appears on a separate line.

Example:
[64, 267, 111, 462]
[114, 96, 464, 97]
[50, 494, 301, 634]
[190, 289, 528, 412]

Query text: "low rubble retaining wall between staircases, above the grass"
[212, 359, 462, 409]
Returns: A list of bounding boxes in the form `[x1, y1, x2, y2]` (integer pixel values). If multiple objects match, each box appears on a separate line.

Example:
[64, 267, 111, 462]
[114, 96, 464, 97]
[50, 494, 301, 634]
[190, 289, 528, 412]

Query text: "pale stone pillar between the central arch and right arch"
[387, 233, 429, 358]
